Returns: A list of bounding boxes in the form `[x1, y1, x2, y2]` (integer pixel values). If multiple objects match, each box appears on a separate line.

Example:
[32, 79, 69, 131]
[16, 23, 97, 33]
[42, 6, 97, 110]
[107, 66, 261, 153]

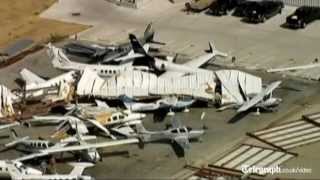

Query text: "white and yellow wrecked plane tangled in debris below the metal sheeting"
[27, 110, 146, 139]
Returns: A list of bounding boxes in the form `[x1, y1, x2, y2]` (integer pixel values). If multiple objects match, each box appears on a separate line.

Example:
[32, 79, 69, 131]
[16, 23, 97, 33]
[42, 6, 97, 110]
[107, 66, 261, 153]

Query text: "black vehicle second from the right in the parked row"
[245, 1, 284, 23]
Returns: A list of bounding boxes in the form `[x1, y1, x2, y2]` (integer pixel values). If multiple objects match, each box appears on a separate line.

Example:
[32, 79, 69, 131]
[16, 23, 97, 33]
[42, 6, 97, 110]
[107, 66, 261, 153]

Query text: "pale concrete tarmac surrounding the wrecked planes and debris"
[0, 0, 320, 179]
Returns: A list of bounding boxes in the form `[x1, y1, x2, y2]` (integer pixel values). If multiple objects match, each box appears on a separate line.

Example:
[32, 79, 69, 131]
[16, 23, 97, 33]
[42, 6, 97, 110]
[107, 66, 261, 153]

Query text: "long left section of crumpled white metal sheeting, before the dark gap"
[77, 70, 222, 100]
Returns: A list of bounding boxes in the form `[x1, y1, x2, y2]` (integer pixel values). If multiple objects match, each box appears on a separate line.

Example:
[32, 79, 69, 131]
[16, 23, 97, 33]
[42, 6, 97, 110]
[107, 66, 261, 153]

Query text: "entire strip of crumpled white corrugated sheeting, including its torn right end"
[77, 70, 261, 103]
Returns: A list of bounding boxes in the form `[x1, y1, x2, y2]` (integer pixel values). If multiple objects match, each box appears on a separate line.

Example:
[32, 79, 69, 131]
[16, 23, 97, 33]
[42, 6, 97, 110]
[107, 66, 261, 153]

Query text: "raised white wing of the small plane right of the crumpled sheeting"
[237, 81, 281, 113]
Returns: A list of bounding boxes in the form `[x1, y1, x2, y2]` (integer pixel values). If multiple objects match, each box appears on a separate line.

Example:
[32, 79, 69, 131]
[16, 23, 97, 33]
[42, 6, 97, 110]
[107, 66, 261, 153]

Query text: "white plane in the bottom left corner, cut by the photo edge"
[0, 160, 94, 180]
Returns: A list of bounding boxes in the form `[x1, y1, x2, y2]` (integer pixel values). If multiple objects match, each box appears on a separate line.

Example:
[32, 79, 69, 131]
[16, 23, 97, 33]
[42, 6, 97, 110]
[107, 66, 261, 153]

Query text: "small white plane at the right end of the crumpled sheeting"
[219, 81, 282, 114]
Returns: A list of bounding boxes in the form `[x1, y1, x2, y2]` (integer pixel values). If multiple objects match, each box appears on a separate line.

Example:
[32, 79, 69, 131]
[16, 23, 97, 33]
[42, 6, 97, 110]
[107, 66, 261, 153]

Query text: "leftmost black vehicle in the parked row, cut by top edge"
[207, 0, 244, 16]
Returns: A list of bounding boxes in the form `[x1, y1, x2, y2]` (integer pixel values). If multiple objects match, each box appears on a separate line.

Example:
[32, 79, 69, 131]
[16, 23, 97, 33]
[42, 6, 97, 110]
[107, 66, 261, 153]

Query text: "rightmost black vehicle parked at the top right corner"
[286, 6, 320, 28]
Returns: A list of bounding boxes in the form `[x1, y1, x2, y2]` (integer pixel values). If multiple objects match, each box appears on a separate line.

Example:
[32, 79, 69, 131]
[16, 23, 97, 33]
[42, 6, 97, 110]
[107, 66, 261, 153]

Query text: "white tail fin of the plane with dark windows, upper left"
[47, 43, 72, 69]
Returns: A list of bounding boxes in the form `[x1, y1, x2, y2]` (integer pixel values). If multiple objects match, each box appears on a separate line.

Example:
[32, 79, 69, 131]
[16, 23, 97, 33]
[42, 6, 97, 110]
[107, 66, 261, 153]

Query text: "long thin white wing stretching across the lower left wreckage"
[15, 138, 139, 161]
